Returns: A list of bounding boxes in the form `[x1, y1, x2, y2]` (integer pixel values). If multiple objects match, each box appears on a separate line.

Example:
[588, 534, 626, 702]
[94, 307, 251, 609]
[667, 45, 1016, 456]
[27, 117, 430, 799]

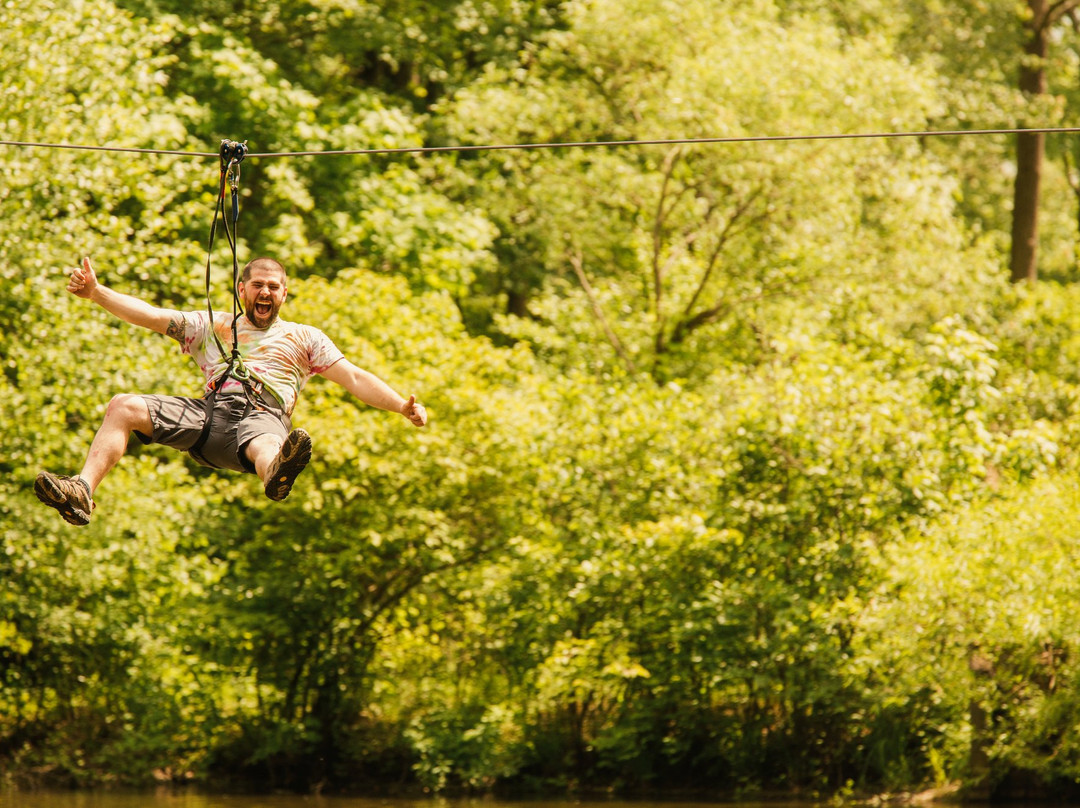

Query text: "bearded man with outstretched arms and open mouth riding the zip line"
[33, 258, 428, 525]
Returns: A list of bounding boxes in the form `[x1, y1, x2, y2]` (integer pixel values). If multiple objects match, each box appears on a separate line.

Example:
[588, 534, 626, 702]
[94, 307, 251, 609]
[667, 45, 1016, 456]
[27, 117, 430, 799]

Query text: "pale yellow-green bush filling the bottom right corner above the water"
[861, 474, 1077, 789]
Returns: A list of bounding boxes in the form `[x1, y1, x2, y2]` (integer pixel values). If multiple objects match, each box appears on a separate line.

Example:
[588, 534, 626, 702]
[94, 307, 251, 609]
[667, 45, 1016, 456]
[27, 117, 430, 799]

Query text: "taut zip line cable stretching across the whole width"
[0, 126, 1080, 159]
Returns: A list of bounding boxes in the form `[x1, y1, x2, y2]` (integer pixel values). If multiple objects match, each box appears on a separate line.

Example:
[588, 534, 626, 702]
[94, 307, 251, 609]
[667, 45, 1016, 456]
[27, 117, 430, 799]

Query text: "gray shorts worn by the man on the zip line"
[135, 393, 293, 473]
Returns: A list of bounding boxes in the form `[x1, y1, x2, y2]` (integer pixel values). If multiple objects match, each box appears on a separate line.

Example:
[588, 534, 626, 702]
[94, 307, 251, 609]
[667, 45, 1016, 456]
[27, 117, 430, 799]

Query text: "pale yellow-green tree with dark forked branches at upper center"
[434, 2, 984, 381]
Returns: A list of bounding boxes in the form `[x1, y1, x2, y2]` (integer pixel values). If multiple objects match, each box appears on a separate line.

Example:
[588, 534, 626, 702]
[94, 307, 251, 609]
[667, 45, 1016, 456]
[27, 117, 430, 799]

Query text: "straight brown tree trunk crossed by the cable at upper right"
[1010, 0, 1049, 283]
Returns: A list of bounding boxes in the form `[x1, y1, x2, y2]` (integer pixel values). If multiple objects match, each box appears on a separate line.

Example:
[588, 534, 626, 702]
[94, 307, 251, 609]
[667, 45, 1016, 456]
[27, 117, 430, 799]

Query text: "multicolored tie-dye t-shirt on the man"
[180, 311, 345, 415]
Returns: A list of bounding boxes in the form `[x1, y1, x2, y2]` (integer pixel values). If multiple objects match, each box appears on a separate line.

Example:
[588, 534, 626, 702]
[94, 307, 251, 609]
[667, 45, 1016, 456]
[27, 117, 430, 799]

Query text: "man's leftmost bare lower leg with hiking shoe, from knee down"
[33, 393, 153, 525]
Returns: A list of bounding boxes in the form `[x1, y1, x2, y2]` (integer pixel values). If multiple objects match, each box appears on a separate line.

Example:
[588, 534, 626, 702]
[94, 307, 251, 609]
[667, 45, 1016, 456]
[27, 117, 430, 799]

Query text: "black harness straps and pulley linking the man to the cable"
[188, 140, 266, 466]
